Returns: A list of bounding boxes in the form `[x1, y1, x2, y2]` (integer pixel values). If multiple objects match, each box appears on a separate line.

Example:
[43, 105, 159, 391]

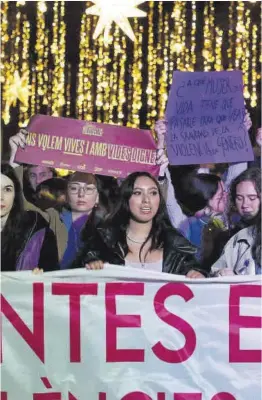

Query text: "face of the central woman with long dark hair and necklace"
[129, 176, 160, 223]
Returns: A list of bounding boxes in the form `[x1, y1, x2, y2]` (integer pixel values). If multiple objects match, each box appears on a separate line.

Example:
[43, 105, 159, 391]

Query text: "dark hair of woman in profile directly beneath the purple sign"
[176, 172, 221, 214]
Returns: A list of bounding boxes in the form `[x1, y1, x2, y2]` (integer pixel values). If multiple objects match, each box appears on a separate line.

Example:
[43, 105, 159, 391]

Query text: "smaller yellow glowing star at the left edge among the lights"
[3, 71, 30, 124]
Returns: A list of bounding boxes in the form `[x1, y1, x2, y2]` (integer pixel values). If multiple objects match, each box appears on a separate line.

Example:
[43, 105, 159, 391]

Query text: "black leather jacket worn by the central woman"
[72, 227, 207, 276]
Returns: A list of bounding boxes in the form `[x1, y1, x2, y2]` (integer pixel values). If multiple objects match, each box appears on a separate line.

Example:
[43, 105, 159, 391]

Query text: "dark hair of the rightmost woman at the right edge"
[228, 168, 261, 226]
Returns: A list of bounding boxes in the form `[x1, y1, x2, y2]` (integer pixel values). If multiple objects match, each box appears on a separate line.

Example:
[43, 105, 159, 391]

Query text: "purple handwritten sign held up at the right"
[166, 71, 254, 165]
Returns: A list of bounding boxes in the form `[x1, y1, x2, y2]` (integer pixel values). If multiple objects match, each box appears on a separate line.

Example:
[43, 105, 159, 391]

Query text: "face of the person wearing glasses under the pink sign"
[67, 182, 99, 214]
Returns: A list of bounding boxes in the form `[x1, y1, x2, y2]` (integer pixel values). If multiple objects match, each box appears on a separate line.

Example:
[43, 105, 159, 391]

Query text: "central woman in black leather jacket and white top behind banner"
[74, 172, 206, 278]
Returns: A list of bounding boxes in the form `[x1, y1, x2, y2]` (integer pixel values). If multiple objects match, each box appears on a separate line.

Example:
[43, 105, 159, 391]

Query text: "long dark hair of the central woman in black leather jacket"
[100, 172, 171, 258]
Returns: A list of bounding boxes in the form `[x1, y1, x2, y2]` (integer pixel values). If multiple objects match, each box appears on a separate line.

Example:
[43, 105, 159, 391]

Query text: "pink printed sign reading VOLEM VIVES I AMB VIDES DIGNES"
[16, 115, 159, 178]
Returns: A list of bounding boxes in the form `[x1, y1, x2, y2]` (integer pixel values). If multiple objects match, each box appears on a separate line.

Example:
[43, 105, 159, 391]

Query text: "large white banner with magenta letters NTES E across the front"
[1, 265, 262, 400]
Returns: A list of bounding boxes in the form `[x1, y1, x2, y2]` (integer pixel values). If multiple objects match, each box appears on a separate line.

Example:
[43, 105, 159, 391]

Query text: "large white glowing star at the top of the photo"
[86, 0, 147, 43]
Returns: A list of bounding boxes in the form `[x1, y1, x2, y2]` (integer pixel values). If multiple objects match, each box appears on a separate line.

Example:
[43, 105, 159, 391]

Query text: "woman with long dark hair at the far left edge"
[1, 163, 58, 271]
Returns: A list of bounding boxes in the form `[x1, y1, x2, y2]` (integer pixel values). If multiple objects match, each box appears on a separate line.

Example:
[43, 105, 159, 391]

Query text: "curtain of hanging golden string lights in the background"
[0, 0, 261, 128]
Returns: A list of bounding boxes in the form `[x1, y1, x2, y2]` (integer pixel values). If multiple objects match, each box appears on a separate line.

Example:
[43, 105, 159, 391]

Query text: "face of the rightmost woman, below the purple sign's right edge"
[236, 181, 260, 219]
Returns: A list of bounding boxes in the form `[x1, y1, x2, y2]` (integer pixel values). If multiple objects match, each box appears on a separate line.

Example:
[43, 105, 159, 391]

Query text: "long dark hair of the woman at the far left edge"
[1, 163, 25, 268]
